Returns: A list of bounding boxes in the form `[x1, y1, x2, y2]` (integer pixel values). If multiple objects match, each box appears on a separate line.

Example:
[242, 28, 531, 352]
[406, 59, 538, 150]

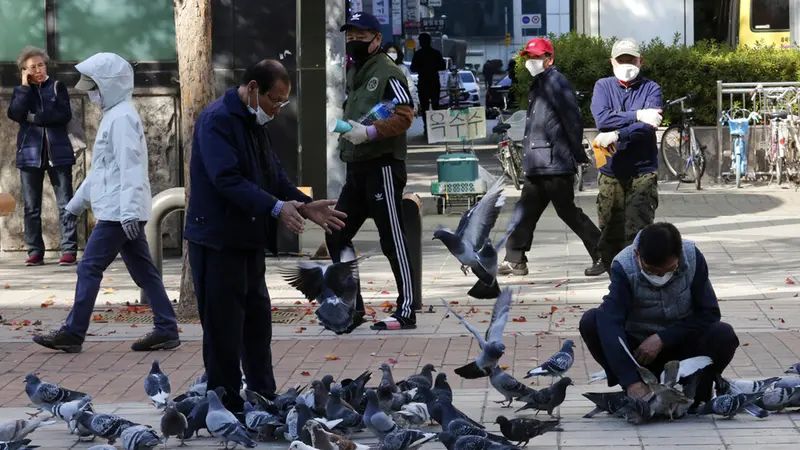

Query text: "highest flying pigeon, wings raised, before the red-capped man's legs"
[433, 178, 521, 299]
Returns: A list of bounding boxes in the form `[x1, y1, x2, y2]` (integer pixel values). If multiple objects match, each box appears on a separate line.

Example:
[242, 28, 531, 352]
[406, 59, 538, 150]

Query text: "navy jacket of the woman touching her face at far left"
[8, 78, 75, 168]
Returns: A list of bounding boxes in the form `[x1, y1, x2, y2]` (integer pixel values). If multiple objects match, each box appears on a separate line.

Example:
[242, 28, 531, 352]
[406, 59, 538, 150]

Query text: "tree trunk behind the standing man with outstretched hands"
[175, 0, 214, 317]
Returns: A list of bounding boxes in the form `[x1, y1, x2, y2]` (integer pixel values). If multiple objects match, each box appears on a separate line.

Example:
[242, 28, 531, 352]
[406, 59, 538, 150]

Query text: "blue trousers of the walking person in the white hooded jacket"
[62, 220, 178, 339]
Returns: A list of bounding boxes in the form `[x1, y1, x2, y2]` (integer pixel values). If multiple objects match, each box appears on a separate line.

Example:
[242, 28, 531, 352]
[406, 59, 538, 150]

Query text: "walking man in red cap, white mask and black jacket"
[499, 38, 600, 275]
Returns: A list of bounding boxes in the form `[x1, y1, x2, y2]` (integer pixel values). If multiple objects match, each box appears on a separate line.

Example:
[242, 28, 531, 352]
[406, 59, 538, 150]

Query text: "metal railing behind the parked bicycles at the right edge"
[717, 80, 800, 183]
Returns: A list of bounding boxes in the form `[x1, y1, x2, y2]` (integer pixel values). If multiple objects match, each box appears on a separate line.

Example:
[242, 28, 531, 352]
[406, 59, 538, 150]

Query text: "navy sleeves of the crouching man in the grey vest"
[597, 249, 721, 387]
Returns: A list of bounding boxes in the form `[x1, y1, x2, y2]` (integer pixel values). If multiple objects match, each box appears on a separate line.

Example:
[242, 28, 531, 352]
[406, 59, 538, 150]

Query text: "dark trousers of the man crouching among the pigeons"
[579, 309, 739, 402]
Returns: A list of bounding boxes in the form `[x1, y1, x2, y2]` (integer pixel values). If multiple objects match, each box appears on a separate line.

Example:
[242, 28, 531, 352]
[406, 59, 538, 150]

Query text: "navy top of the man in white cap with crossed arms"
[592, 77, 662, 178]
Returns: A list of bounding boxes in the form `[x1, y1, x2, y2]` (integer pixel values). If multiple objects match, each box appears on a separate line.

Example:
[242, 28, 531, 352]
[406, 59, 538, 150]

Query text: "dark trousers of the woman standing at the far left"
[20, 166, 78, 256]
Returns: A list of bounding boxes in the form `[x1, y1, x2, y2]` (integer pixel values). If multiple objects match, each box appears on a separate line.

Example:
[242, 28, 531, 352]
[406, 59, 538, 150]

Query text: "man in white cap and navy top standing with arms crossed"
[585, 39, 662, 276]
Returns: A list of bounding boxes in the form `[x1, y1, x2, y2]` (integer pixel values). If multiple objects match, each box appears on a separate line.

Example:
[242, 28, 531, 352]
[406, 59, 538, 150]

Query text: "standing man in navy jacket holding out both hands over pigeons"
[185, 60, 346, 412]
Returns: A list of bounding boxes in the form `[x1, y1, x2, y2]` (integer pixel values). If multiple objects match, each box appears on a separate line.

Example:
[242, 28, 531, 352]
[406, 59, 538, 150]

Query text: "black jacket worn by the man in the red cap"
[522, 66, 589, 176]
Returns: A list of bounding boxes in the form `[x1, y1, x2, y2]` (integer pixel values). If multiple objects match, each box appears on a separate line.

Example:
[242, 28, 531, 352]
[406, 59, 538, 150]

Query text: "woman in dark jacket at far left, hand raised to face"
[8, 47, 78, 266]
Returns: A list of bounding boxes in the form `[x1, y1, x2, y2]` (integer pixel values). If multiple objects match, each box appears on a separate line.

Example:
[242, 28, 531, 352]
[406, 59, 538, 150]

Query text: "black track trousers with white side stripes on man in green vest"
[326, 158, 419, 323]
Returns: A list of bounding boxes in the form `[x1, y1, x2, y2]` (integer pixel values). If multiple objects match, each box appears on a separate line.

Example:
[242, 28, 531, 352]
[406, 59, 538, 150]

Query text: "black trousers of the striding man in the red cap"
[505, 175, 600, 263]
